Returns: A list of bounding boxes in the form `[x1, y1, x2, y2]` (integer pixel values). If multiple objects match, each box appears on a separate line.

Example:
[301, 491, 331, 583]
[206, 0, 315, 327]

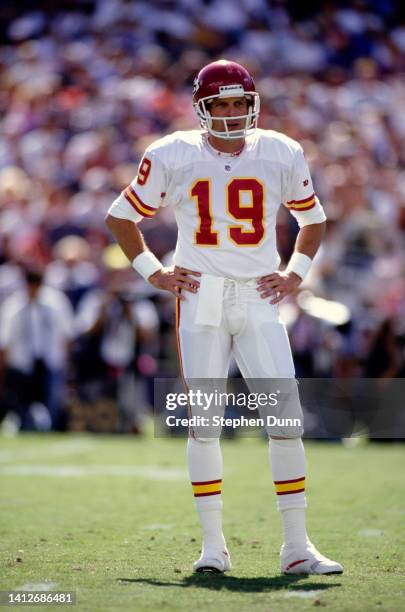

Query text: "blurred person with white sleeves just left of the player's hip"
[75, 281, 159, 431]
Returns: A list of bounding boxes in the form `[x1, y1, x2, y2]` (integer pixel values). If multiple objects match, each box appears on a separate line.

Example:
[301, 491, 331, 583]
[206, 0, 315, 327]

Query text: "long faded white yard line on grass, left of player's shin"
[0, 465, 187, 481]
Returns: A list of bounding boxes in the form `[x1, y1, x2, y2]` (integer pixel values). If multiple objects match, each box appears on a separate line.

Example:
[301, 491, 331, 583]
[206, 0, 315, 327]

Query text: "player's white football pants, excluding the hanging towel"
[177, 279, 303, 438]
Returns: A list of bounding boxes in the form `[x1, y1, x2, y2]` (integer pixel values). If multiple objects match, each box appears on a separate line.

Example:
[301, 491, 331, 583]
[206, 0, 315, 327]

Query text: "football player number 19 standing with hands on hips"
[106, 60, 343, 574]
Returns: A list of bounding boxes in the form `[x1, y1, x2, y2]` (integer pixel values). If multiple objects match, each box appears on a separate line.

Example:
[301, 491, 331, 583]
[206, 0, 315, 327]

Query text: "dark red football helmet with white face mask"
[193, 60, 260, 139]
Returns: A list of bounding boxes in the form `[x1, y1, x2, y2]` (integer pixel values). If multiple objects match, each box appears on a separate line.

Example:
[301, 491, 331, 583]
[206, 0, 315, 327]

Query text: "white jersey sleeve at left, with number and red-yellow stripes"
[108, 145, 168, 223]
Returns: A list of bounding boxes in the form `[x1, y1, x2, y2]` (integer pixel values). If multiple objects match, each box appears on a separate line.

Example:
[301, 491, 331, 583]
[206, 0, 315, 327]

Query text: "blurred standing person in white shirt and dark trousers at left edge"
[0, 268, 73, 430]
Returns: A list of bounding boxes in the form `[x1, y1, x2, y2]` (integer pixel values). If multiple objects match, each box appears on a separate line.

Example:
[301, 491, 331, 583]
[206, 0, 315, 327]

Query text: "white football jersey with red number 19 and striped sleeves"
[109, 129, 326, 279]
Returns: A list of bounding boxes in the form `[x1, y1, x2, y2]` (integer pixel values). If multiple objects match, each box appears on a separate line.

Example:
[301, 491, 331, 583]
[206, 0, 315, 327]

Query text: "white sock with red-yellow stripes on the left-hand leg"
[187, 438, 226, 553]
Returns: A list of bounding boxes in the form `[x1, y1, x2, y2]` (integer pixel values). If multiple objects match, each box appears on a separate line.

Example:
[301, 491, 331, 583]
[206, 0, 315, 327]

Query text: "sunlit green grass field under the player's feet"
[0, 435, 405, 612]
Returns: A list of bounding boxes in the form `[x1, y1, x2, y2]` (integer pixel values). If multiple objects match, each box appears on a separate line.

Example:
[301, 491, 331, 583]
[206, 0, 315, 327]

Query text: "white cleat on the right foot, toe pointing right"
[280, 541, 343, 575]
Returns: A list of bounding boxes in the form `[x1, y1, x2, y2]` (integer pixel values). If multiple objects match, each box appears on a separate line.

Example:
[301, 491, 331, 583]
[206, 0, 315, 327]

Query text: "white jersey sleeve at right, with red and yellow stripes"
[283, 147, 326, 227]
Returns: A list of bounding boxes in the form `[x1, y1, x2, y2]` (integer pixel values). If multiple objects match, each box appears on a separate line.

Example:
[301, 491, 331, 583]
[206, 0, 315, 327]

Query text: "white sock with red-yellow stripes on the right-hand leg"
[269, 438, 307, 548]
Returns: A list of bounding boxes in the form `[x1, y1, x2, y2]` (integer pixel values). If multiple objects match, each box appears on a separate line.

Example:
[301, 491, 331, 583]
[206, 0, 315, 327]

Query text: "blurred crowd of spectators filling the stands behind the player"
[0, 0, 405, 432]
